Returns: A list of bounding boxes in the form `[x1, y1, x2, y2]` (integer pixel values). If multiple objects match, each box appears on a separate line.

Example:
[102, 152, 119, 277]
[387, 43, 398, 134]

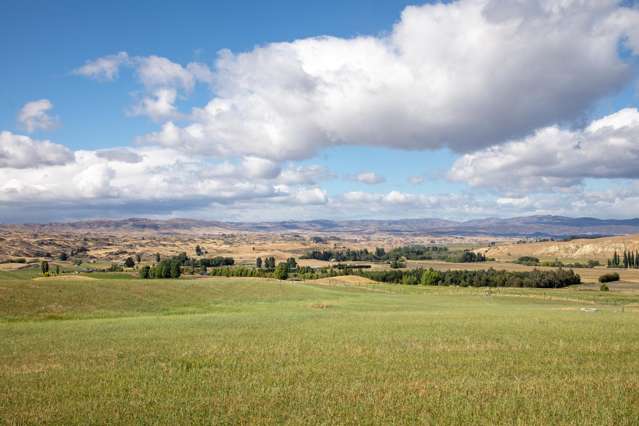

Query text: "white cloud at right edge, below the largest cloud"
[449, 108, 639, 191]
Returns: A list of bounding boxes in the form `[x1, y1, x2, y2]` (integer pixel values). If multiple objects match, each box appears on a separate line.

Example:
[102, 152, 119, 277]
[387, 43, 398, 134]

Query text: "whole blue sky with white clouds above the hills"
[0, 0, 639, 222]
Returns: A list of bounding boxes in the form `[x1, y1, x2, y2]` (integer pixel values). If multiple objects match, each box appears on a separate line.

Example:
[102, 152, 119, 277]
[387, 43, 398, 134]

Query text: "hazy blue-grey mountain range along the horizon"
[12, 216, 639, 238]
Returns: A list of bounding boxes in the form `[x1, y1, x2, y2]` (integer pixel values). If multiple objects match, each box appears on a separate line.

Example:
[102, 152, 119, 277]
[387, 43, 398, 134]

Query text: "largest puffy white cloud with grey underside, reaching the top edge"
[145, 0, 639, 160]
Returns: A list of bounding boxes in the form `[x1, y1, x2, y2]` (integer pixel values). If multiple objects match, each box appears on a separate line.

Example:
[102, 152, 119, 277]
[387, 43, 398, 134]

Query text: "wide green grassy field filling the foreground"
[0, 274, 639, 425]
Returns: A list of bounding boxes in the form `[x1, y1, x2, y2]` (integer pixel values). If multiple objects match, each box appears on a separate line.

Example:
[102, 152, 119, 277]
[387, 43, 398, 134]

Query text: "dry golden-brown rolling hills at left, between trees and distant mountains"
[0, 226, 512, 266]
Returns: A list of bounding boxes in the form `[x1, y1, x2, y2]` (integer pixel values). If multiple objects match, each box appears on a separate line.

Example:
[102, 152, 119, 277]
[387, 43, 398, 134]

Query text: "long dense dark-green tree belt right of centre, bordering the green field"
[359, 268, 581, 288]
